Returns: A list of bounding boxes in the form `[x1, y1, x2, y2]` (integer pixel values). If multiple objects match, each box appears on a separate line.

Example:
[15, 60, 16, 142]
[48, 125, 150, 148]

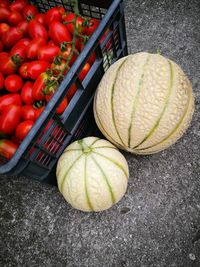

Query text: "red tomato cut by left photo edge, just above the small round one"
[0, 52, 18, 75]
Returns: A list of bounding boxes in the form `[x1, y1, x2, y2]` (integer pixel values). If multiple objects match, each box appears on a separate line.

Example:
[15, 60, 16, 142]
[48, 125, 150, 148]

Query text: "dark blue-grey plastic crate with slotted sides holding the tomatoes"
[0, 0, 127, 182]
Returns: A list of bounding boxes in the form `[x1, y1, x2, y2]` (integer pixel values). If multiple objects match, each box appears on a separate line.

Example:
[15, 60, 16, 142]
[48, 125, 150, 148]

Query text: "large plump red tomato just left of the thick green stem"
[49, 20, 72, 45]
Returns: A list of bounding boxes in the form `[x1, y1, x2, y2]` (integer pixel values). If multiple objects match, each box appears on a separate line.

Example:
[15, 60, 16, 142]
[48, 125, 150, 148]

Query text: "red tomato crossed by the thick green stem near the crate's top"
[62, 12, 84, 34]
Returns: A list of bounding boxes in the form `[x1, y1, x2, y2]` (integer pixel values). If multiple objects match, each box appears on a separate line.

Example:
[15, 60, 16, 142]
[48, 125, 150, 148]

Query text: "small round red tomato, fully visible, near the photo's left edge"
[4, 74, 23, 93]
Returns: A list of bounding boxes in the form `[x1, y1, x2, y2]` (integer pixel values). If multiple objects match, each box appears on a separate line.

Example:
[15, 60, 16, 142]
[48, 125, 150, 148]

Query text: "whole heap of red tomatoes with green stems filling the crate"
[0, 0, 99, 159]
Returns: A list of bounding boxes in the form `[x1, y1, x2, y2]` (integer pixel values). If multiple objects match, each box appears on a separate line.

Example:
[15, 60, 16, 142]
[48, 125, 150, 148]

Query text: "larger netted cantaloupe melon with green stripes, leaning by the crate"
[94, 52, 194, 154]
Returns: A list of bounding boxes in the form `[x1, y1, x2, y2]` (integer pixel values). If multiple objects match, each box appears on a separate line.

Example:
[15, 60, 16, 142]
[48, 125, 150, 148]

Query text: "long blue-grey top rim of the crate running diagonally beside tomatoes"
[0, 0, 123, 174]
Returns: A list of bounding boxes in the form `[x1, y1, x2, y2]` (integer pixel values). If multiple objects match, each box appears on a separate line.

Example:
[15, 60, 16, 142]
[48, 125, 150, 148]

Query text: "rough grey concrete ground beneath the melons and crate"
[0, 0, 200, 267]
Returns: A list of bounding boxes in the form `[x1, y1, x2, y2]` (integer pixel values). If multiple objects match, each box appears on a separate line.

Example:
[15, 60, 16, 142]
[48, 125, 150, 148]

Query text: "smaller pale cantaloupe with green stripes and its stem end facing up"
[56, 137, 129, 211]
